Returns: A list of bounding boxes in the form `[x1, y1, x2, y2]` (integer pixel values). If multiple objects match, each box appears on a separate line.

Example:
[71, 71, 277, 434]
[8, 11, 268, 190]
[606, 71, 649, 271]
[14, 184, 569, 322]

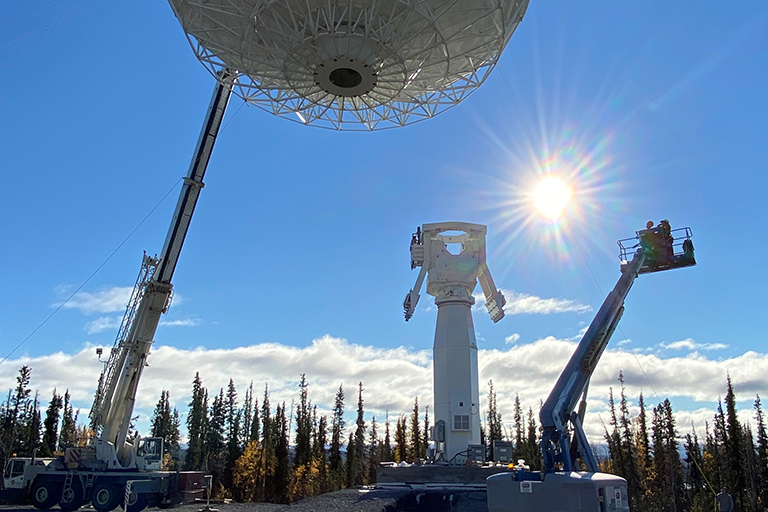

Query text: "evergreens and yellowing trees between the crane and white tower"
[176, 374, 436, 503]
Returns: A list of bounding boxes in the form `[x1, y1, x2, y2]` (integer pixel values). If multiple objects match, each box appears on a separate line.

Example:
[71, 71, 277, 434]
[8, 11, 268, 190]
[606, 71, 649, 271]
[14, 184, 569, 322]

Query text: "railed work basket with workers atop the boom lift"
[617, 224, 696, 274]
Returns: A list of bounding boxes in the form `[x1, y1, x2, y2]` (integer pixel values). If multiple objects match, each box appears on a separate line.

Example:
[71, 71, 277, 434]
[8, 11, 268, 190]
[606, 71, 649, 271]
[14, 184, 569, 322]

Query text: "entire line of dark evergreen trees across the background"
[0, 366, 768, 512]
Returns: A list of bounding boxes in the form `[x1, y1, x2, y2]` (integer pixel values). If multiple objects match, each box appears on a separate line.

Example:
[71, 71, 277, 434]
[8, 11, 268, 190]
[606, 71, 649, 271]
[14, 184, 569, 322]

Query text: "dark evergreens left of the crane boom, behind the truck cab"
[0, 365, 90, 467]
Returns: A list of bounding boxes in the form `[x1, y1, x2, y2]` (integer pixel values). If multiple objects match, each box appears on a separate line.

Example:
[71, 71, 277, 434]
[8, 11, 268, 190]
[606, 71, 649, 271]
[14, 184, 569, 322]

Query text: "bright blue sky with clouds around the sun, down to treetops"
[0, 0, 768, 435]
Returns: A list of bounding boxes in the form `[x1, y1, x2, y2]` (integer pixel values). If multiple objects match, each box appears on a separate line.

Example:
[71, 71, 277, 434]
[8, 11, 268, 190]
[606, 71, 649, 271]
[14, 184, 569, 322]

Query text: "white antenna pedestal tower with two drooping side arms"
[403, 222, 506, 464]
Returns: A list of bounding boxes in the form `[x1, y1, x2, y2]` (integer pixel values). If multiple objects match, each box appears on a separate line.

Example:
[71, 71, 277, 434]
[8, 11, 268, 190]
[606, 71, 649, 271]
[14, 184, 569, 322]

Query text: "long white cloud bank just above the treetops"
[0, 335, 768, 442]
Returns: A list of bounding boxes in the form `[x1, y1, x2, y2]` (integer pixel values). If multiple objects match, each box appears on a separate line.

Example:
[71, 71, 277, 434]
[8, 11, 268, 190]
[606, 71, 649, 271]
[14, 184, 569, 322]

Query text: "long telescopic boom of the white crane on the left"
[92, 70, 234, 467]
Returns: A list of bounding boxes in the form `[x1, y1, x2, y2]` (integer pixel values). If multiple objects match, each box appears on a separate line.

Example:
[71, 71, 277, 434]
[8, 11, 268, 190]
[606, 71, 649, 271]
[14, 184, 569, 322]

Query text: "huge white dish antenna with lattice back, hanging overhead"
[169, 0, 529, 130]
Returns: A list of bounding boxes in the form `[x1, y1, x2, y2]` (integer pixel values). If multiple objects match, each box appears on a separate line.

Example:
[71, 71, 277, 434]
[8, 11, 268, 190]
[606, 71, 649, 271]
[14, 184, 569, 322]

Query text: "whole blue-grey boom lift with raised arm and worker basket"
[486, 224, 696, 512]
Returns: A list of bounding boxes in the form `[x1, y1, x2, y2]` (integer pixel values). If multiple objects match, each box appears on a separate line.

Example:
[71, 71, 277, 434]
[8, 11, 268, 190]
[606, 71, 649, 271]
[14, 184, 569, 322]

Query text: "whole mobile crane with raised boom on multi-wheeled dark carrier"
[12, 70, 234, 512]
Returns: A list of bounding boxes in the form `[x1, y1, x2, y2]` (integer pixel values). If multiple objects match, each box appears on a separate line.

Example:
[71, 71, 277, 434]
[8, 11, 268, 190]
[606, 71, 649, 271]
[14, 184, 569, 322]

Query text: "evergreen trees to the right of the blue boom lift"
[601, 373, 768, 512]
